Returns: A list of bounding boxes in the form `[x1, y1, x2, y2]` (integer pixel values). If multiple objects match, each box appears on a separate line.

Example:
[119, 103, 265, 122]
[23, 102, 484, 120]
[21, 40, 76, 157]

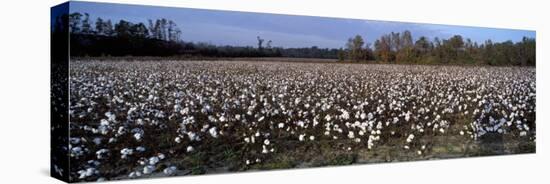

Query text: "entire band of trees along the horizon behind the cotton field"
[52, 13, 536, 66]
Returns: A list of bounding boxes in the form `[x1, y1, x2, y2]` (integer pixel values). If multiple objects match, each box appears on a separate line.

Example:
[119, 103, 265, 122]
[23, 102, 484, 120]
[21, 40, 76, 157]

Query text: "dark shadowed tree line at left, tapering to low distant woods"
[62, 12, 339, 59]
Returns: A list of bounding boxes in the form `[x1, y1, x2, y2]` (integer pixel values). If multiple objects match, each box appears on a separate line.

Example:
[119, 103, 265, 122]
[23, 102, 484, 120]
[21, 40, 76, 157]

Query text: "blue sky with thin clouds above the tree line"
[70, 1, 535, 48]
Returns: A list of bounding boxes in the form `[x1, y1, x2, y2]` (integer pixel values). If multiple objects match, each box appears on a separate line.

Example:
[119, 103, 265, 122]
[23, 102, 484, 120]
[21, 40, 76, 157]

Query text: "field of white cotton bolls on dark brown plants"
[68, 61, 536, 181]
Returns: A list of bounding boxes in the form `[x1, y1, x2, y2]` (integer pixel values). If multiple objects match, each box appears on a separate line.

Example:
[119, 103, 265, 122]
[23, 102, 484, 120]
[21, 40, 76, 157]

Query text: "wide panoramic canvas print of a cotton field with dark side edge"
[51, 1, 536, 182]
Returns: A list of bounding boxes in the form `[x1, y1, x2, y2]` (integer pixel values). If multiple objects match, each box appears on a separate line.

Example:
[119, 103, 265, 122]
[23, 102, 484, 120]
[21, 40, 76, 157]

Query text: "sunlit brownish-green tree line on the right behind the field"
[338, 30, 536, 66]
